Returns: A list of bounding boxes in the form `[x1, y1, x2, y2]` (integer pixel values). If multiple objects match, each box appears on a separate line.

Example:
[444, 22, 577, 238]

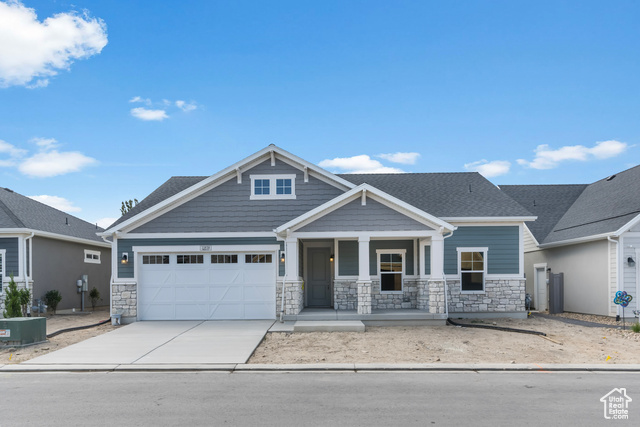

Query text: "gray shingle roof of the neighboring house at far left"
[0, 187, 104, 243]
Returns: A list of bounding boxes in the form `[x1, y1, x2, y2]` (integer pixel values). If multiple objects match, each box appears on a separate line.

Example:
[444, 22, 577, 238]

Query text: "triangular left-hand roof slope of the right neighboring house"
[500, 184, 587, 243]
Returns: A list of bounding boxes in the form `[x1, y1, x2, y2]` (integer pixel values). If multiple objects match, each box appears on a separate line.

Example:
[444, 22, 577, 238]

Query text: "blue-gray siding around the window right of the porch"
[444, 226, 520, 274]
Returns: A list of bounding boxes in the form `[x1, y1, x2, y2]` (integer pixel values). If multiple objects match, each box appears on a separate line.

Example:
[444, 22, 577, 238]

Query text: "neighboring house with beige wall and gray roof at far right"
[500, 166, 640, 317]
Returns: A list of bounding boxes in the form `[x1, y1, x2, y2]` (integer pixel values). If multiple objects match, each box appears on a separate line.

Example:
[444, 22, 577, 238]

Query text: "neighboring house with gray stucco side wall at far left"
[0, 187, 111, 316]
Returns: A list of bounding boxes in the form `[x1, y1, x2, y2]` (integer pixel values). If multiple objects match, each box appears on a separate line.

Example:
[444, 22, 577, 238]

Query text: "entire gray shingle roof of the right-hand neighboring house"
[501, 166, 640, 244]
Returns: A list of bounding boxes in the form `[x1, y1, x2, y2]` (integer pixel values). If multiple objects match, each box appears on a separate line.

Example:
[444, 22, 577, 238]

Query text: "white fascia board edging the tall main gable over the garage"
[100, 145, 355, 236]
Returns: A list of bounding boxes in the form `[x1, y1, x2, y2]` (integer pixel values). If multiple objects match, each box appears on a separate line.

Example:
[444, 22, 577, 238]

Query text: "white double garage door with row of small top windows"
[138, 253, 277, 320]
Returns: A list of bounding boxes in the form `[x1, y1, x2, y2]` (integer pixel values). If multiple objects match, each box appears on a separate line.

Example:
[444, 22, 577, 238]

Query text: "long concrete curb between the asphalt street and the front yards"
[0, 363, 640, 373]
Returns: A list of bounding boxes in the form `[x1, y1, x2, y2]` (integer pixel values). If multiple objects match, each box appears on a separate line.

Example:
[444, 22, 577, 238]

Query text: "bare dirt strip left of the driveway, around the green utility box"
[0, 307, 118, 365]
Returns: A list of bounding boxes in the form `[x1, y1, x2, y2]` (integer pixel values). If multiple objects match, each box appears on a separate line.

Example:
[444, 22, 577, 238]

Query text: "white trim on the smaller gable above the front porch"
[274, 184, 457, 234]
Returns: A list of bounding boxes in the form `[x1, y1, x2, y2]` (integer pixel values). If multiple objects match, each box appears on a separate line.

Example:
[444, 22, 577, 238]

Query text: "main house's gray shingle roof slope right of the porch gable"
[338, 172, 532, 218]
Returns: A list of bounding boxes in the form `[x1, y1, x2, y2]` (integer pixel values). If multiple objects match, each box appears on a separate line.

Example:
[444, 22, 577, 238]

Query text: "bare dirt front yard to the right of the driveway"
[249, 315, 640, 364]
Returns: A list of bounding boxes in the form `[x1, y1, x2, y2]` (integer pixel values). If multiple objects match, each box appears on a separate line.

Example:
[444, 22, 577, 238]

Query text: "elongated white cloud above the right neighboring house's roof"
[518, 140, 629, 169]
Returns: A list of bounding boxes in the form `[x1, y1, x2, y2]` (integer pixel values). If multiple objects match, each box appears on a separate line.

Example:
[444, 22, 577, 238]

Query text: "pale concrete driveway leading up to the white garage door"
[23, 320, 274, 366]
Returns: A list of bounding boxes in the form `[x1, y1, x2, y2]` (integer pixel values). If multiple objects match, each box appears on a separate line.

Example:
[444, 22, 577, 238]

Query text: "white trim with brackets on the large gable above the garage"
[98, 144, 355, 236]
